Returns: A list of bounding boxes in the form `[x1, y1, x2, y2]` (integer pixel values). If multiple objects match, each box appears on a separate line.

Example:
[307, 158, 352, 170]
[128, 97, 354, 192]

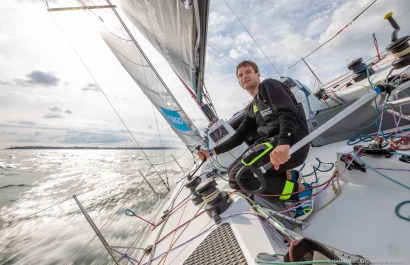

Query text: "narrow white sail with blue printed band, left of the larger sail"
[79, 1, 203, 151]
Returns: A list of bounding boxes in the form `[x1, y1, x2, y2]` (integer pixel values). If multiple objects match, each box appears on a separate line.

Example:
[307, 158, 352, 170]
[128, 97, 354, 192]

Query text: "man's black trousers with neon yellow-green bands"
[228, 137, 310, 200]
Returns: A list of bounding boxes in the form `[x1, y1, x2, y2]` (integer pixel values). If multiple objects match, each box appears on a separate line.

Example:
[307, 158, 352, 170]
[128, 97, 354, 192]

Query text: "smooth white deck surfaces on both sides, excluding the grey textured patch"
[133, 127, 410, 264]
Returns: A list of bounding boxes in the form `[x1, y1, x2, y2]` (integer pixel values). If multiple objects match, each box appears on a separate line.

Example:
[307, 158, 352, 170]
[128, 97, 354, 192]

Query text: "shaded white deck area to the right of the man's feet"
[296, 137, 410, 264]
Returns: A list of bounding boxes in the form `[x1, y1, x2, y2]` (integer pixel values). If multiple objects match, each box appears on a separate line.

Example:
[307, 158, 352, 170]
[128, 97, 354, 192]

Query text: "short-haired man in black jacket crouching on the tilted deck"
[197, 61, 313, 220]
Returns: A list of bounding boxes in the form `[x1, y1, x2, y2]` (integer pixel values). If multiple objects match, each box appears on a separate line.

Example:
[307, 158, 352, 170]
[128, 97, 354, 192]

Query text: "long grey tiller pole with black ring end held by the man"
[236, 86, 382, 194]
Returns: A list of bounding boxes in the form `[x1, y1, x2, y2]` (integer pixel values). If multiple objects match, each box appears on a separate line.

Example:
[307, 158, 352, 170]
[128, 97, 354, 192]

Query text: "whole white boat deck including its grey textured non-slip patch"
[133, 122, 410, 264]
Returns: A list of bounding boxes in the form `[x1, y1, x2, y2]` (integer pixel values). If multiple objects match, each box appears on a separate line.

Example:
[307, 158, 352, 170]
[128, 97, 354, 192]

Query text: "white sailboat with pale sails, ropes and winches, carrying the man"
[49, 0, 410, 264]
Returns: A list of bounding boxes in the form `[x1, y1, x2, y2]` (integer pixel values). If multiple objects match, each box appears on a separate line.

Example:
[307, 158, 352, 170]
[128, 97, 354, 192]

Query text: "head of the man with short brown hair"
[236, 61, 260, 97]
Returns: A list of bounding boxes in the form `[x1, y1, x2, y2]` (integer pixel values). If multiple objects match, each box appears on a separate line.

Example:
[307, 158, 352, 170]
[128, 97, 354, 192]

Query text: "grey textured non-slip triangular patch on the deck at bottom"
[184, 223, 248, 265]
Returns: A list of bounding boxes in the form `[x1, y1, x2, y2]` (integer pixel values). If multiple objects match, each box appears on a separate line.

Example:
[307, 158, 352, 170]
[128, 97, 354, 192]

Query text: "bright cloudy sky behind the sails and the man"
[0, 0, 410, 149]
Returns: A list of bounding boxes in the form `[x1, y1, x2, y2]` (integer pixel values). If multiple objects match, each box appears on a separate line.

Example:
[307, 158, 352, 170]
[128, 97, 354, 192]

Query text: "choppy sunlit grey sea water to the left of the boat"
[0, 149, 192, 264]
